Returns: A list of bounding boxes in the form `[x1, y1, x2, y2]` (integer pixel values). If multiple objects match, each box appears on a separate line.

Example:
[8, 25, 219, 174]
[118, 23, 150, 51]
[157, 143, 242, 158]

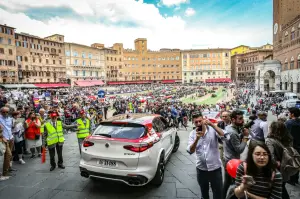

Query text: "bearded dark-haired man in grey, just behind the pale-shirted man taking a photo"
[223, 110, 249, 199]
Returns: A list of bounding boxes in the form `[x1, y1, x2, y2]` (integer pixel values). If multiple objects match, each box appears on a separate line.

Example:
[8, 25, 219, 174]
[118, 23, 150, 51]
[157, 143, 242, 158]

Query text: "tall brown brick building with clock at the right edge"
[273, 0, 300, 93]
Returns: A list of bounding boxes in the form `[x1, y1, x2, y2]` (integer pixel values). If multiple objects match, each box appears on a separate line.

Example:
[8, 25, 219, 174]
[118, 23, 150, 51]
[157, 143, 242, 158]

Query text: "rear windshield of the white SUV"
[93, 123, 145, 140]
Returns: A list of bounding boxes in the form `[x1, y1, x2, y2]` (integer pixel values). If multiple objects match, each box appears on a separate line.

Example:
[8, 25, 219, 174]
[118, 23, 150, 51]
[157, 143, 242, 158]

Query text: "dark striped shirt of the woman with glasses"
[235, 163, 282, 199]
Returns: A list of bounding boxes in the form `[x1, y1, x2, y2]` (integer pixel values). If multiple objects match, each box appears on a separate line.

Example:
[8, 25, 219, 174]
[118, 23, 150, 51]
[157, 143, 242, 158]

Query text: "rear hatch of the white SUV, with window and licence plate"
[82, 122, 145, 170]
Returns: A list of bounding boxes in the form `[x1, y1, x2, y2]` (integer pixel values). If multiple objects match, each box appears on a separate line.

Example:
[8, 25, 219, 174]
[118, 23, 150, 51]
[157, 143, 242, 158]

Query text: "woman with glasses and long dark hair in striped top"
[234, 141, 282, 199]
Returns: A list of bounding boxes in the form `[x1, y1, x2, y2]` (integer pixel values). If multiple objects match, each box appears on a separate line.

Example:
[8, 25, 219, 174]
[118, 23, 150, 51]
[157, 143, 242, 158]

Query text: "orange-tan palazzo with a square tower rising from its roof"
[122, 38, 181, 82]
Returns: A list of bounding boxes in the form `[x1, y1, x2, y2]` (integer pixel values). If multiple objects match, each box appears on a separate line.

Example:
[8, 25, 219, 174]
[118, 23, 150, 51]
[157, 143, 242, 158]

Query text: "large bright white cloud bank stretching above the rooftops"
[0, 0, 272, 50]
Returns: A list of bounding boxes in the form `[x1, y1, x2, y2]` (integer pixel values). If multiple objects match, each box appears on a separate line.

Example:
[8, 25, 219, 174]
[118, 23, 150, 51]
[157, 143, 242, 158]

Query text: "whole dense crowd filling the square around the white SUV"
[0, 84, 300, 199]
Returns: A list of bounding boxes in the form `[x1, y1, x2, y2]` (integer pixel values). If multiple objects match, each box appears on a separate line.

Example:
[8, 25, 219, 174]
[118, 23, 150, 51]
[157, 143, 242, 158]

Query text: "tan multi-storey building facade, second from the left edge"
[15, 33, 66, 83]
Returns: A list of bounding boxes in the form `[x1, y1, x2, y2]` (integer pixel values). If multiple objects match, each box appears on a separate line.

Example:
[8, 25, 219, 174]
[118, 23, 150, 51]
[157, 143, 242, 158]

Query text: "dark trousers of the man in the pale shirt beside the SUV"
[197, 168, 223, 199]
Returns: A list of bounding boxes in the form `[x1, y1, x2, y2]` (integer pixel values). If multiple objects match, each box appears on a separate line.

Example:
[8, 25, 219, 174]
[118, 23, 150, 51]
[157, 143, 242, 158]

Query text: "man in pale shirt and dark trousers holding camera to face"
[187, 112, 224, 199]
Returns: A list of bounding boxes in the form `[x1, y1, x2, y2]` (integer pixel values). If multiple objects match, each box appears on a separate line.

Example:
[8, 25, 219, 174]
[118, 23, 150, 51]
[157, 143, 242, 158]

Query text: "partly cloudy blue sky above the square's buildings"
[0, 0, 273, 50]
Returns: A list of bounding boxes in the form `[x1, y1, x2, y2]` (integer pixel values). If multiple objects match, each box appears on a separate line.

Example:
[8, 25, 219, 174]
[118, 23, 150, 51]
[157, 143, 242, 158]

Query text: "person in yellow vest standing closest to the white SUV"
[76, 110, 91, 154]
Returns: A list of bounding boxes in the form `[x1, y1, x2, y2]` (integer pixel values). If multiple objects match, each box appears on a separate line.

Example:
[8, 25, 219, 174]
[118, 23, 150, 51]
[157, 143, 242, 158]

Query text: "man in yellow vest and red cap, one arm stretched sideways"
[44, 112, 77, 171]
